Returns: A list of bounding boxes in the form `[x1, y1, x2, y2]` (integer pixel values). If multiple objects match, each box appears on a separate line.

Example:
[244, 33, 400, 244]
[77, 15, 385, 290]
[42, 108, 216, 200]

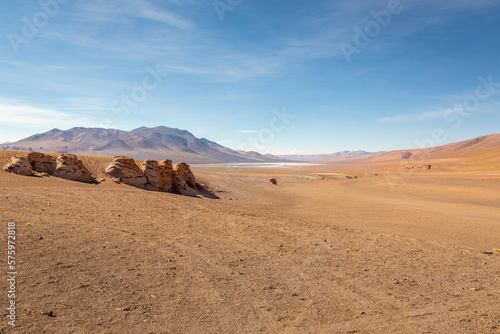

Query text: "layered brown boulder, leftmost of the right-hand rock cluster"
[104, 157, 148, 189]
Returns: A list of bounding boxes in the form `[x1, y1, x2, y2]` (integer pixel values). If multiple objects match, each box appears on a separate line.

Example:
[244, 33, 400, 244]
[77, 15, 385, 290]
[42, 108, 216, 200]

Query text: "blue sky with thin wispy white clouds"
[0, 0, 500, 153]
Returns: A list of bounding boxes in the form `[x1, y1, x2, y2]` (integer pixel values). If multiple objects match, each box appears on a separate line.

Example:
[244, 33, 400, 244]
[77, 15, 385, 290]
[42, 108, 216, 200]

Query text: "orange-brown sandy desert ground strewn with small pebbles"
[0, 153, 500, 333]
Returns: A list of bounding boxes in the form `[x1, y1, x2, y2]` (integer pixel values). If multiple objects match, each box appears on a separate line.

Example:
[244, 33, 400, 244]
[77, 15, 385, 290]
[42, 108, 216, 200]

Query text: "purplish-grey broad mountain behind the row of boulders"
[0, 126, 286, 163]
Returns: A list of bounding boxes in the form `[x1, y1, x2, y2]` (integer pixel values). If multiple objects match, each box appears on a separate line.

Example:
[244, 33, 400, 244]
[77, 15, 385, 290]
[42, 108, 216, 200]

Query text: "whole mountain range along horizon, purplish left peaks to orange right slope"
[0, 126, 500, 168]
